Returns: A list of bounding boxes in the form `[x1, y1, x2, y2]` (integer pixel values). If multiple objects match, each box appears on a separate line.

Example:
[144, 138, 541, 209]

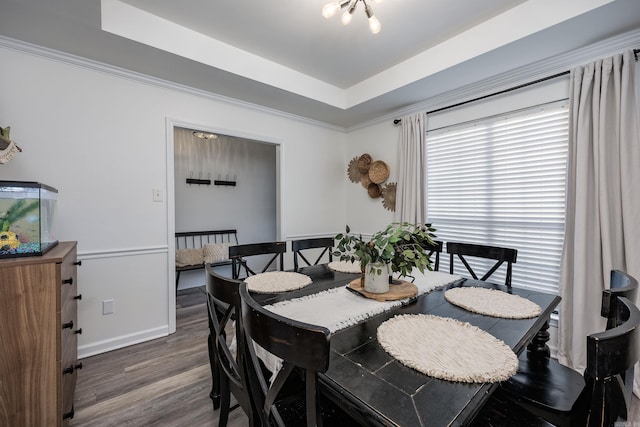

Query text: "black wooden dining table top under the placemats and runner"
[253, 265, 560, 427]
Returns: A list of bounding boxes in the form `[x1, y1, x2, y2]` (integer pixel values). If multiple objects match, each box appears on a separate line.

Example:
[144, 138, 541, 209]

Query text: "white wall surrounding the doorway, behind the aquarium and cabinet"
[0, 42, 347, 356]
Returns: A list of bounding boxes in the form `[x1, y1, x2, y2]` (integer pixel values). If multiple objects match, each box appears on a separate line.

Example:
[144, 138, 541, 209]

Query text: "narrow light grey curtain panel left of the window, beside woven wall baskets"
[395, 113, 427, 224]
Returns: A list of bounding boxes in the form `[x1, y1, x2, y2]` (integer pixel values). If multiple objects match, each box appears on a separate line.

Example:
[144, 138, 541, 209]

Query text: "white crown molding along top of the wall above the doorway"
[0, 36, 345, 133]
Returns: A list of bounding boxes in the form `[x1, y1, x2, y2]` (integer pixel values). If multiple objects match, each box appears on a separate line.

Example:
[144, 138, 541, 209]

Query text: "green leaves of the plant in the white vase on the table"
[333, 222, 436, 276]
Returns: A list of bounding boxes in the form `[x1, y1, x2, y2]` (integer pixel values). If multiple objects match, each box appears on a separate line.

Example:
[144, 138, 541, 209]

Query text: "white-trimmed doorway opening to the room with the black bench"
[167, 118, 281, 333]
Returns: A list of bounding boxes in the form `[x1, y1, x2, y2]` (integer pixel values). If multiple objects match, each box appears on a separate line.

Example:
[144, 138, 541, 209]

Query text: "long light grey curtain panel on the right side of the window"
[558, 51, 640, 395]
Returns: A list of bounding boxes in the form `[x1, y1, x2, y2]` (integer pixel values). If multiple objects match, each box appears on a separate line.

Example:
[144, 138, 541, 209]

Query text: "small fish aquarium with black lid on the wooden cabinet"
[0, 181, 58, 258]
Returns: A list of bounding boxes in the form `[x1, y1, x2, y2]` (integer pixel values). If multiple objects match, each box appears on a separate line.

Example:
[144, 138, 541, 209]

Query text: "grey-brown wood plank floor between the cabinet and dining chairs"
[70, 288, 640, 427]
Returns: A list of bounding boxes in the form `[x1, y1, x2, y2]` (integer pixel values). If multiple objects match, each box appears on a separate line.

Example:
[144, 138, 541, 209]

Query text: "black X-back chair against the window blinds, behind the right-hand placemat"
[447, 242, 518, 288]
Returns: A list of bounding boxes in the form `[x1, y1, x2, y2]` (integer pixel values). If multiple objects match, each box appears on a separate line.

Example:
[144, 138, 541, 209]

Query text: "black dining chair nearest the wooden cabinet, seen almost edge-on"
[206, 266, 260, 427]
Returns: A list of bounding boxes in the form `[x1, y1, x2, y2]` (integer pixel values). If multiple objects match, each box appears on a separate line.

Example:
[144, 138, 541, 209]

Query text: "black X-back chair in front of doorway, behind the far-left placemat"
[229, 242, 287, 279]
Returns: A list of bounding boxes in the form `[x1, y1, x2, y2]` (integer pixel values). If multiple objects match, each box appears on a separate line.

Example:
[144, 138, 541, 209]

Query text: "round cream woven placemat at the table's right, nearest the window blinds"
[444, 287, 542, 319]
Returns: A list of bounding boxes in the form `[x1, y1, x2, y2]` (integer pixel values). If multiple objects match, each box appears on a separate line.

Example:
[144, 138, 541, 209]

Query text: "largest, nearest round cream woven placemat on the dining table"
[378, 314, 518, 383]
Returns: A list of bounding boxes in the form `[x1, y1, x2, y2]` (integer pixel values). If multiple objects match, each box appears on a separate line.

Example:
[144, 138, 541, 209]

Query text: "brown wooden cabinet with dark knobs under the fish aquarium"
[0, 242, 82, 427]
